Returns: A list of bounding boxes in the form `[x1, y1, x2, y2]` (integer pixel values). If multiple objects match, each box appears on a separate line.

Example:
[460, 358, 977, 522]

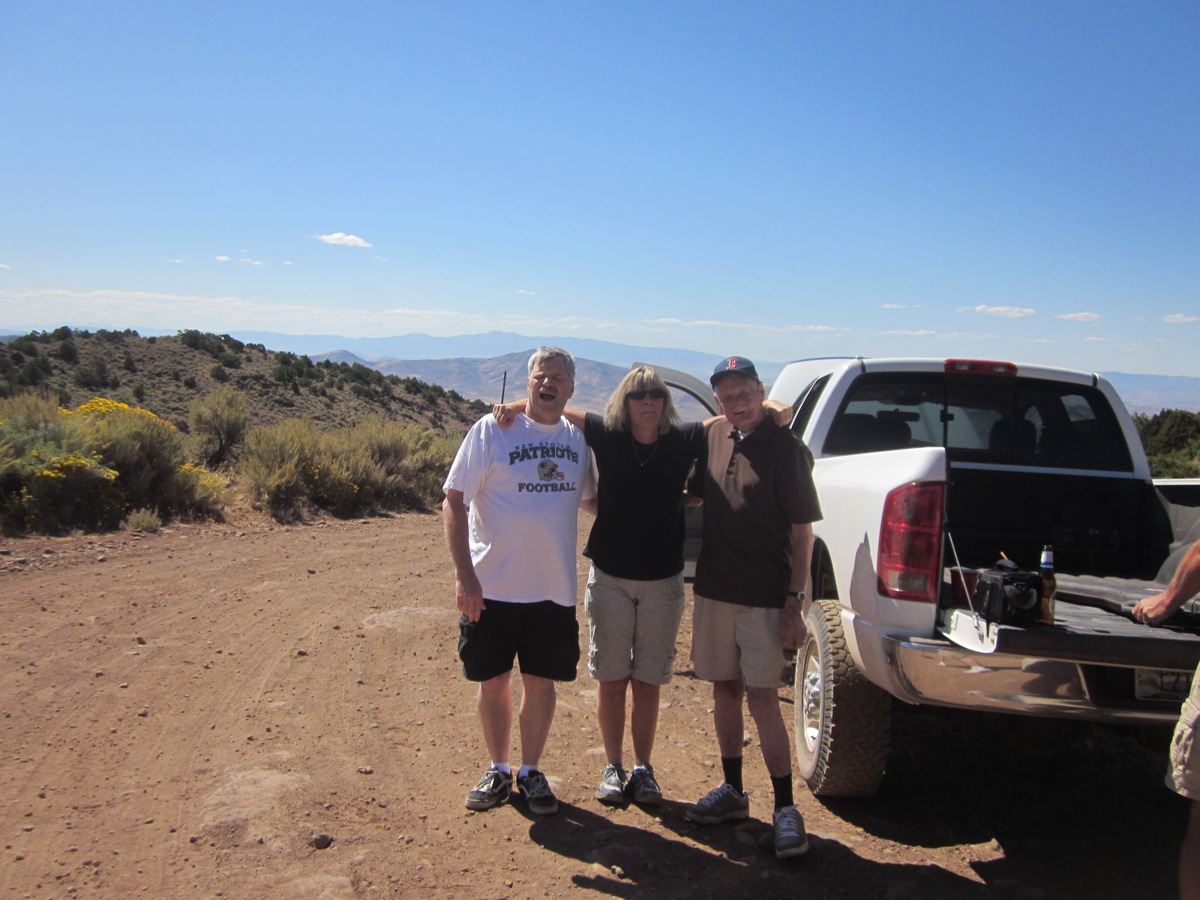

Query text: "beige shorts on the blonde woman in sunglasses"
[583, 565, 684, 685]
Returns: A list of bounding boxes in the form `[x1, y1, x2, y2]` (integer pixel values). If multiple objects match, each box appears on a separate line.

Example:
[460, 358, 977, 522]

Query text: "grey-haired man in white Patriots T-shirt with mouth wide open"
[442, 347, 595, 815]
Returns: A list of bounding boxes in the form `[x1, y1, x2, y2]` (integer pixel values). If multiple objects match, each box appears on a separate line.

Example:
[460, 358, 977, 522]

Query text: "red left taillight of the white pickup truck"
[876, 481, 943, 604]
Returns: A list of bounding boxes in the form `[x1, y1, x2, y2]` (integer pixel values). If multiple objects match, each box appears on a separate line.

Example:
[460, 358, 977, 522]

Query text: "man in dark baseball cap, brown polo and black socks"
[684, 356, 821, 858]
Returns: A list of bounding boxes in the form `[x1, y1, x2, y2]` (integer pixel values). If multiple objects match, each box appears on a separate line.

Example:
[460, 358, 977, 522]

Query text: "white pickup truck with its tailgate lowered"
[658, 359, 1200, 797]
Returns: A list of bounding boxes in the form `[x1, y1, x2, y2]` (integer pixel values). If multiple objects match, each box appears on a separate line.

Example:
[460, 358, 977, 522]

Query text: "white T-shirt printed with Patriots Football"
[443, 415, 595, 606]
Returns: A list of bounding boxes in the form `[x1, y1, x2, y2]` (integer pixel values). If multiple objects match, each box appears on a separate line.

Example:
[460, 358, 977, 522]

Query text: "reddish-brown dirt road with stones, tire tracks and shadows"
[0, 515, 1186, 900]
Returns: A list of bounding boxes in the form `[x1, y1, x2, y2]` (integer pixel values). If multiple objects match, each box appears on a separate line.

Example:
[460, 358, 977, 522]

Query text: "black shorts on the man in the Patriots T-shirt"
[458, 599, 580, 682]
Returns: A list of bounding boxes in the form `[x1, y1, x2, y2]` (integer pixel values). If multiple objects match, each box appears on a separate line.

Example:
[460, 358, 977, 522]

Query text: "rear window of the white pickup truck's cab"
[823, 372, 1133, 472]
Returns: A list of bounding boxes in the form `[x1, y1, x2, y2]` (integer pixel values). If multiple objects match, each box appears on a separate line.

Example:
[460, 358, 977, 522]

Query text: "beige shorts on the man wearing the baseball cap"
[691, 595, 785, 688]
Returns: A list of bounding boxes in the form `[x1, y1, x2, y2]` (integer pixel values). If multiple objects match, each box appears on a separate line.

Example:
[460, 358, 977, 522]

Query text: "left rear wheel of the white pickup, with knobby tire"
[796, 600, 892, 797]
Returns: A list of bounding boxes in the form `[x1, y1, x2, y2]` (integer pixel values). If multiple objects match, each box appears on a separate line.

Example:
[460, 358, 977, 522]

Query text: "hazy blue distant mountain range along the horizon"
[0, 331, 1200, 416]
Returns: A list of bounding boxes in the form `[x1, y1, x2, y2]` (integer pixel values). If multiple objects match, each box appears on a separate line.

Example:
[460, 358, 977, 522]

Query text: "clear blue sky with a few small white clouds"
[0, 0, 1200, 376]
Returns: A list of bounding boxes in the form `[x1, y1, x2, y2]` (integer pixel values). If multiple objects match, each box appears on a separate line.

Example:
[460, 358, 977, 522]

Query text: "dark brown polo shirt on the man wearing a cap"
[689, 416, 821, 607]
